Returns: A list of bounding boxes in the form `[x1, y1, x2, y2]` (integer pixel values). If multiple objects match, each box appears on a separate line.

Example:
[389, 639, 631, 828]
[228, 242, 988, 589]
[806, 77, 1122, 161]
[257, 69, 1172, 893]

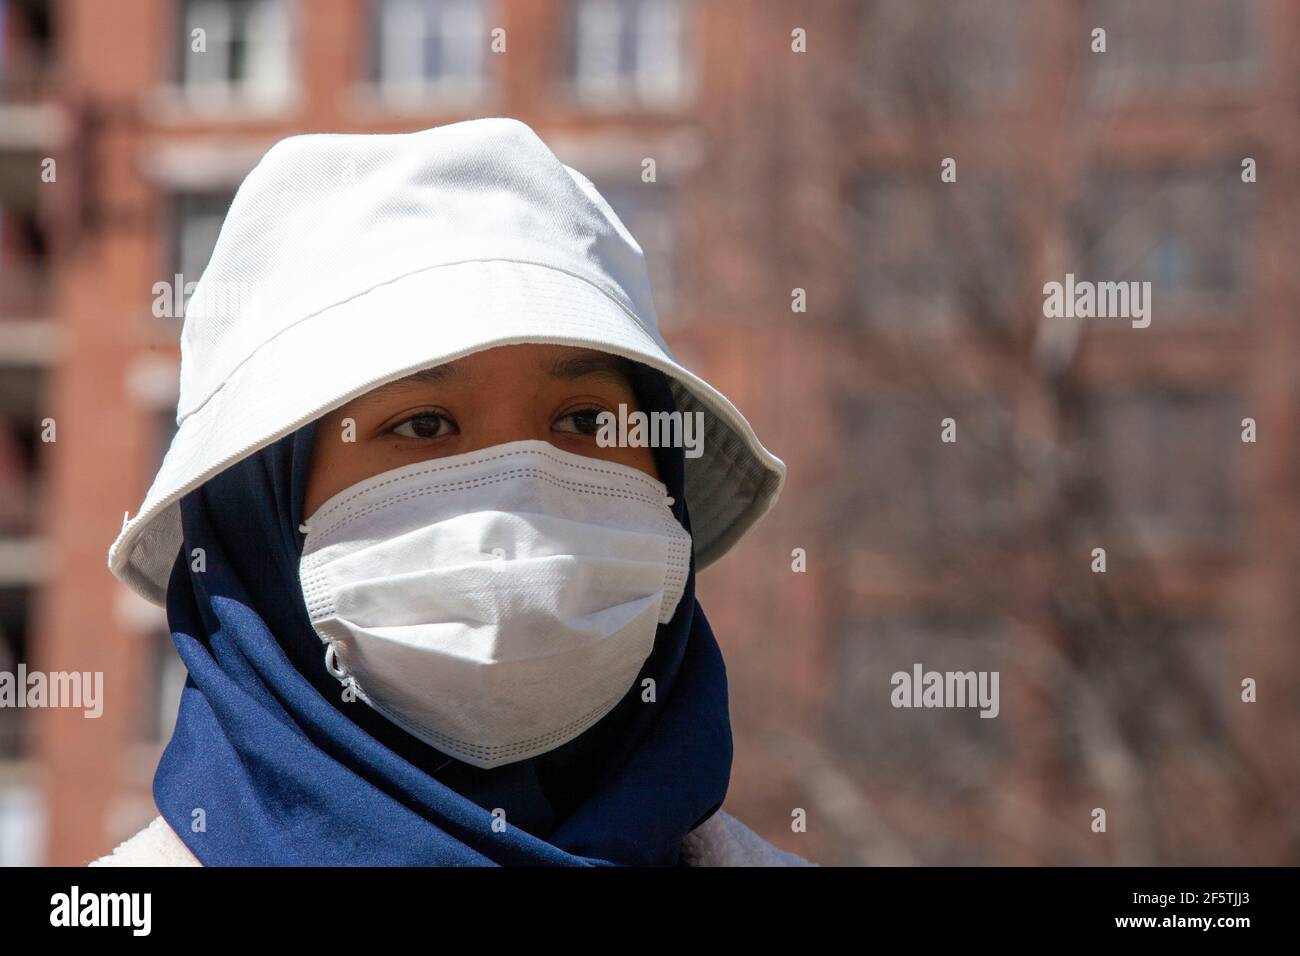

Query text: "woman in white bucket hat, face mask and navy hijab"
[92, 118, 807, 866]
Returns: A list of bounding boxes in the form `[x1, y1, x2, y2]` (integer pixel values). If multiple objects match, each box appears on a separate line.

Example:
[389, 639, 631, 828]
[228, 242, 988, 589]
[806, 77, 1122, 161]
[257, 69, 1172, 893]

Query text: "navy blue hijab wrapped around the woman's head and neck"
[153, 367, 732, 866]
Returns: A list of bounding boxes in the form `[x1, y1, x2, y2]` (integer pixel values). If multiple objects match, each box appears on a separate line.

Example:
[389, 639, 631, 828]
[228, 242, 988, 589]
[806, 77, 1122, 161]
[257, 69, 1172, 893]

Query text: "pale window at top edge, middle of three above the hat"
[371, 0, 490, 103]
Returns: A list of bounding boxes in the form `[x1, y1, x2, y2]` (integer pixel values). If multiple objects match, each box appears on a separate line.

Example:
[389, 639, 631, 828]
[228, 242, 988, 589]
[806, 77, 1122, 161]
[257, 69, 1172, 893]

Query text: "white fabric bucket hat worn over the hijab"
[108, 117, 785, 606]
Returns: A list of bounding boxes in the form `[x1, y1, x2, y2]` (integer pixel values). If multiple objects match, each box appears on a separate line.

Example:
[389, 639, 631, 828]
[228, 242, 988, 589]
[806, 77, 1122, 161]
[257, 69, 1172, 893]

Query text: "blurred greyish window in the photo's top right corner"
[1086, 0, 1260, 92]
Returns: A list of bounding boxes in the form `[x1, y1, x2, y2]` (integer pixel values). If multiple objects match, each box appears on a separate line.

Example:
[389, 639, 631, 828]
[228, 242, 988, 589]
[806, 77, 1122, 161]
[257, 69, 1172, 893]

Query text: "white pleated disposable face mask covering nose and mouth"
[299, 441, 690, 767]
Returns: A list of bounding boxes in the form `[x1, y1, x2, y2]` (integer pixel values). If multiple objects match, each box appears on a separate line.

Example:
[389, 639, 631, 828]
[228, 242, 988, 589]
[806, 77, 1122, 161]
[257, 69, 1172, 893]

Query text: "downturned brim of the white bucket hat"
[108, 259, 785, 606]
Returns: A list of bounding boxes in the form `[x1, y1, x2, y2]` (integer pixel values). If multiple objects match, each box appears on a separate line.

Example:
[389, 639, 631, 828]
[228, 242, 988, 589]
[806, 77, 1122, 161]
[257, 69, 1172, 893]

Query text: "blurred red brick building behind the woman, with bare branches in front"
[0, 0, 1300, 864]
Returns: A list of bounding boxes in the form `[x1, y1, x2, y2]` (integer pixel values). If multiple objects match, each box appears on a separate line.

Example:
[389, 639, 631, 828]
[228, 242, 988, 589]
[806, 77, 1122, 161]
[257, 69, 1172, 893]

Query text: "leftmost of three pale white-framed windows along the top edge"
[178, 0, 291, 107]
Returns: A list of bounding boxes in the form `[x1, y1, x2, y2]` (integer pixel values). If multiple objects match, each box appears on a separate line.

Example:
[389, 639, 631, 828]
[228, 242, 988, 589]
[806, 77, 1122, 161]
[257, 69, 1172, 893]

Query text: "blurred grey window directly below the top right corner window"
[1074, 166, 1253, 303]
